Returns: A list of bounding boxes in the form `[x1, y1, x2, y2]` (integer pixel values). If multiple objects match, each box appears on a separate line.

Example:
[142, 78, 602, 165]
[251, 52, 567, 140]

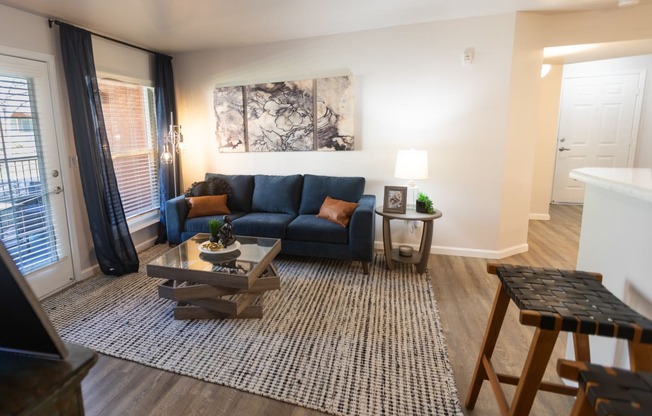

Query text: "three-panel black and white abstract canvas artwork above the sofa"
[213, 76, 354, 152]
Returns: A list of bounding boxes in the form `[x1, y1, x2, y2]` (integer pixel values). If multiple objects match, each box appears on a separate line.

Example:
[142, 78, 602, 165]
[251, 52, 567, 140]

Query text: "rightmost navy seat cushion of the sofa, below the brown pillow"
[287, 214, 349, 244]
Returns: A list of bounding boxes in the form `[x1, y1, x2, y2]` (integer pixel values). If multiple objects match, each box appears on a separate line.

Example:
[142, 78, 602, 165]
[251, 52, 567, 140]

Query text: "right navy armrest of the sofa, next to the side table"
[349, 195, 376, 261]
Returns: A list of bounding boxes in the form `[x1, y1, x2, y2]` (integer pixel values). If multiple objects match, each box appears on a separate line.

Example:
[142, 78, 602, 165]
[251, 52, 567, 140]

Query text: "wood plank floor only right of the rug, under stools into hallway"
[429, 205, 582, 416]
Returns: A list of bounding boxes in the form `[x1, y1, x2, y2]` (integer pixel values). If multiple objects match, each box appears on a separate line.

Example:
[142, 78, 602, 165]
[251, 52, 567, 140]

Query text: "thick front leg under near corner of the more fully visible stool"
[509, 328, 559, 415]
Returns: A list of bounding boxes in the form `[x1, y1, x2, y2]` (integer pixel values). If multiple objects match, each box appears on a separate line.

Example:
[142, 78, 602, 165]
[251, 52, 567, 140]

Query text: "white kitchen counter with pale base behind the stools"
[566, 168, 652, 368]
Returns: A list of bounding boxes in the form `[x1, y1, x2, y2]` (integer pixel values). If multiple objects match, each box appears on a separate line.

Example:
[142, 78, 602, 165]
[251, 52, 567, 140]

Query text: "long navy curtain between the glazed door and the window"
[59, 23, 138, 276]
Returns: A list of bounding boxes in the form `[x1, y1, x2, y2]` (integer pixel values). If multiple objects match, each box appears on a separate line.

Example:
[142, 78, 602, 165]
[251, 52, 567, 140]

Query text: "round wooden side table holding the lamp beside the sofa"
[376, 205, 441, 273]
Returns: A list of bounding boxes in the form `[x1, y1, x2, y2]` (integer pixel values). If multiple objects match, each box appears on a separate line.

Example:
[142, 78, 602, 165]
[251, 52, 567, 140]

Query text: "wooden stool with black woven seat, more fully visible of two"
[466, 264, 652, 415]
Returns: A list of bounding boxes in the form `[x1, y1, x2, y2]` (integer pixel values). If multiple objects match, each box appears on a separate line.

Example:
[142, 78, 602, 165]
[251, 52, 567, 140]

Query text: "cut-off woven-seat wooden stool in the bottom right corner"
[557, 360, 652, 416]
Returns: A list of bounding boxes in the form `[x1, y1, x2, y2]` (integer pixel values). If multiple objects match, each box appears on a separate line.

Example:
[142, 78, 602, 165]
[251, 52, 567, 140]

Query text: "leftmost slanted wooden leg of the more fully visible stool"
[466, 285, 509, 409]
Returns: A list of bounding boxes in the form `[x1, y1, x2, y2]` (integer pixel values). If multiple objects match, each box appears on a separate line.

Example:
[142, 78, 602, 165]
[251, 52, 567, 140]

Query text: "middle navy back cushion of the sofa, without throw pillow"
[251, 175, 304, 215]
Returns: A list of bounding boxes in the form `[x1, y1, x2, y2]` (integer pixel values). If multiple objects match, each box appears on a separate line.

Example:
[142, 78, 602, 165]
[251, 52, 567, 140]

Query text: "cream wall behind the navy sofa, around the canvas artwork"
[173, 15, 529, 257]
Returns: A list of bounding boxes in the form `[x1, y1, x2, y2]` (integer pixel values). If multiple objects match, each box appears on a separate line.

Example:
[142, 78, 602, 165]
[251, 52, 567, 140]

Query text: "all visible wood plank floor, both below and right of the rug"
[82, 206, 582, 416]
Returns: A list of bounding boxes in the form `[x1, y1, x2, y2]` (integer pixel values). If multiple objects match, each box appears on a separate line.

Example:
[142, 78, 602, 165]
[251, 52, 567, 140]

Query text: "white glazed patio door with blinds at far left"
[0, 54, 73, 297]
